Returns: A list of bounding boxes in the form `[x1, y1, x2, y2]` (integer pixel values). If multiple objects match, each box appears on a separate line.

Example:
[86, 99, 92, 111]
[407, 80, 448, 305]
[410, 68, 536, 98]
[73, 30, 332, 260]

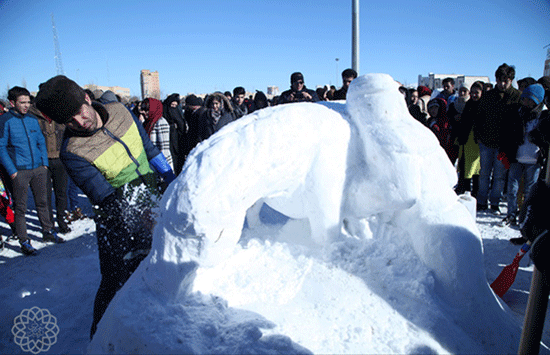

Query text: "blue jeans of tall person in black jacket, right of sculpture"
[477, 142, 506, 206]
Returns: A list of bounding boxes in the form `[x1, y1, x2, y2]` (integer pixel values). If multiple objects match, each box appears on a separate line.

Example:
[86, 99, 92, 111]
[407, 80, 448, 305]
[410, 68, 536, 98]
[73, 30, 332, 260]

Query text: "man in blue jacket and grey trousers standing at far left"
[0, 86, 64, 255]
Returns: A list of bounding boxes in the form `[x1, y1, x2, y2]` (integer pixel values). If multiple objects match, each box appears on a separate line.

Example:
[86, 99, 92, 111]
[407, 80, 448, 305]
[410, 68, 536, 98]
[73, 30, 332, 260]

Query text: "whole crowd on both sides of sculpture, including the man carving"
[0, 64, 550, 336]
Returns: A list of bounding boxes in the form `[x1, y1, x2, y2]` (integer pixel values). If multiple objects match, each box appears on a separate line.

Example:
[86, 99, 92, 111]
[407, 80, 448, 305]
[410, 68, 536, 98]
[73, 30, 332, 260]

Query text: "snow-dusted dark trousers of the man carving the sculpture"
[90, 216, 152, 339]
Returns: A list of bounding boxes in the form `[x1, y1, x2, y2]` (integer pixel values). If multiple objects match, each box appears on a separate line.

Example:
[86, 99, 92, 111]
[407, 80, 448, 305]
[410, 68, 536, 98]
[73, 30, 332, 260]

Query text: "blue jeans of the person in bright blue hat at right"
[506, 163, 540, 216]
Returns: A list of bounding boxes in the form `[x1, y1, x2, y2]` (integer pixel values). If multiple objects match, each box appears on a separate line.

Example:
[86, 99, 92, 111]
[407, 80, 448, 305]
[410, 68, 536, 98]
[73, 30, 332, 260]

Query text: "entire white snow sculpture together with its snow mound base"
[88, 74, 521, 354]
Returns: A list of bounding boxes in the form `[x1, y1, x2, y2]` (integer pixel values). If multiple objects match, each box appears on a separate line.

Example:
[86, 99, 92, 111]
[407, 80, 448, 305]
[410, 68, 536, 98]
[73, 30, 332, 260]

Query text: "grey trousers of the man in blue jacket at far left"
[12, 166, 53, 242]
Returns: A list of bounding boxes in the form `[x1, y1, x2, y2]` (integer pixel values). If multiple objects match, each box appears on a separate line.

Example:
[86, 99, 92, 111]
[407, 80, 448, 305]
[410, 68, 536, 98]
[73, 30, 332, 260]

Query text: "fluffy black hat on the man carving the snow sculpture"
[36, 75, 86, 124]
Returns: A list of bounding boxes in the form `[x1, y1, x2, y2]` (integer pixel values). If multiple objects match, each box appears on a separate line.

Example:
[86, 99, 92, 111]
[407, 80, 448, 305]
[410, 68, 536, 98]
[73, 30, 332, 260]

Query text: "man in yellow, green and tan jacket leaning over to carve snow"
[36, 75, 175, 336]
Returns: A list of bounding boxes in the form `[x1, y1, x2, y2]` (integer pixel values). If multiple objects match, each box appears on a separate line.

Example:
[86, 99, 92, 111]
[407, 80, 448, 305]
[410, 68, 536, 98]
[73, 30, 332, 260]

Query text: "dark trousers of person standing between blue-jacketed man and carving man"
[48, 158, 69, 228]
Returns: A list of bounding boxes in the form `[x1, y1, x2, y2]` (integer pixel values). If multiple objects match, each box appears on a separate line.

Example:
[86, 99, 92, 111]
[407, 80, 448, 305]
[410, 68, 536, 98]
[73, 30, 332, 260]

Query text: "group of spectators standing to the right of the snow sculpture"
[402, 63, 550, 243]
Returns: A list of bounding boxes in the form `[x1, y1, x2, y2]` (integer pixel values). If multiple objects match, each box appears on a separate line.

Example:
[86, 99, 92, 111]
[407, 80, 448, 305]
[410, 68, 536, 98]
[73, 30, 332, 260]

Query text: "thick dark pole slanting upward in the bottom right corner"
[518, 152, 550, 355]
